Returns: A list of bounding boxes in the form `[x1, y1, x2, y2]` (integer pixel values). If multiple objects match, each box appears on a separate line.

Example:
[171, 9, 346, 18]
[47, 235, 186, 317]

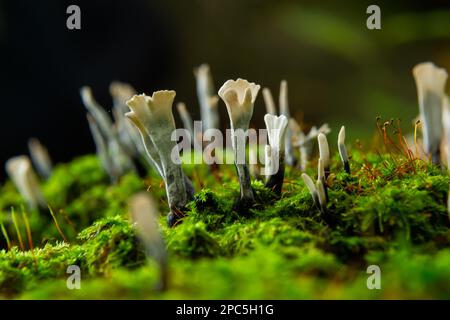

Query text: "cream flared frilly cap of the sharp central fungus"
[219, 78, 260, 130]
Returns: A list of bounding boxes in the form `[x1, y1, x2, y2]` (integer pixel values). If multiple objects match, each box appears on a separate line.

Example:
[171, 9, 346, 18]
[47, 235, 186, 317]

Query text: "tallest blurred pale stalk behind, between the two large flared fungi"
[194, 64, 219, 132]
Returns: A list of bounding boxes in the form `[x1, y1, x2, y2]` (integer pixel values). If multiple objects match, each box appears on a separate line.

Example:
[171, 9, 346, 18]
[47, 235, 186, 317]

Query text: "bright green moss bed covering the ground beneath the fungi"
[0, 146, 450, 299]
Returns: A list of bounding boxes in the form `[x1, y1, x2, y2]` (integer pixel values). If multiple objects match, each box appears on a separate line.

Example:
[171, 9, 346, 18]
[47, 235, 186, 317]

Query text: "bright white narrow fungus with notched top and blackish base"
[264, 114, 288, 195]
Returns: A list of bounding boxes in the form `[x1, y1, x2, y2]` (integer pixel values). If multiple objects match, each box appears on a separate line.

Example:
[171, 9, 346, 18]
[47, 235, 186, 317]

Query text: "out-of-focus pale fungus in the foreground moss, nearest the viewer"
[130, 192, 168, 291]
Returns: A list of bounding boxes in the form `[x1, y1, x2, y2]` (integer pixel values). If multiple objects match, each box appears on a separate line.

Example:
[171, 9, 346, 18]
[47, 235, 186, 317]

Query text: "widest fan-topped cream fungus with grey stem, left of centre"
[126, 90, 193, 226]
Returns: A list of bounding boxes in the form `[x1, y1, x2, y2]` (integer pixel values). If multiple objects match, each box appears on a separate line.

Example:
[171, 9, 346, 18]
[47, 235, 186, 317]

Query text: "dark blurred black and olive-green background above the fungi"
[0, 0, 450, 177]
